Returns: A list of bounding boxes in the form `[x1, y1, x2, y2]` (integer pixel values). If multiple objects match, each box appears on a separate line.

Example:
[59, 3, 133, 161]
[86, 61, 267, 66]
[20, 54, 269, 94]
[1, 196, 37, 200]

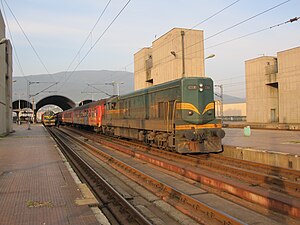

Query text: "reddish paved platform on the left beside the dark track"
[0, 124, 99, 225]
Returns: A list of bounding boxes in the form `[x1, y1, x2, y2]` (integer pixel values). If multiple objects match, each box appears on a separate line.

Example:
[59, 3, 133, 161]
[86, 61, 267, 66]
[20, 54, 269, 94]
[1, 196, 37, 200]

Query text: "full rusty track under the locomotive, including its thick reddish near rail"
[61, 126, 299, 219]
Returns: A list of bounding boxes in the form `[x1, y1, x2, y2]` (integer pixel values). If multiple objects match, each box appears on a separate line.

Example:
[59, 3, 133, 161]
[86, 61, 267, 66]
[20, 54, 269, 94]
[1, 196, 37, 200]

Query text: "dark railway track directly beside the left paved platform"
[47, 128, 152, 225]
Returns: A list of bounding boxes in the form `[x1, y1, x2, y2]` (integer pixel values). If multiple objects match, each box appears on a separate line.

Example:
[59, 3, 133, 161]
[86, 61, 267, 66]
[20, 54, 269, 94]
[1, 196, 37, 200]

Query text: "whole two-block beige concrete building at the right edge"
[245, 47, 300, 129]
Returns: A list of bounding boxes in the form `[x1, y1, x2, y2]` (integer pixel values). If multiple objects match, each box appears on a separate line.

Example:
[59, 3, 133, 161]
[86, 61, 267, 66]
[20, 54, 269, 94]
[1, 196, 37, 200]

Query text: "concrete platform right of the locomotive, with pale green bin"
[222, 128, 300, 170]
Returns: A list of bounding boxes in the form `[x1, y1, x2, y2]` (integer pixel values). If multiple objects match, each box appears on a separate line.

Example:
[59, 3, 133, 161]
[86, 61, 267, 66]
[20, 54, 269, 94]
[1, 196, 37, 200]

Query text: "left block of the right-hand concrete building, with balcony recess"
[245, 56, 279, 123]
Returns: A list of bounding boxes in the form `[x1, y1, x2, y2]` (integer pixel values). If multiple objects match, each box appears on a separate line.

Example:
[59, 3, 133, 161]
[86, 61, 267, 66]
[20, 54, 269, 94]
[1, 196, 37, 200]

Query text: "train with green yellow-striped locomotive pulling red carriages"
[57, 77, 225, 153]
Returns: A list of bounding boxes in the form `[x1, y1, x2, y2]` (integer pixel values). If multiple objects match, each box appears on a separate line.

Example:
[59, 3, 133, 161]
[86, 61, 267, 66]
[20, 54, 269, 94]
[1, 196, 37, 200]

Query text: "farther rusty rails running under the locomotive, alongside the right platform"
[78, 127, 300, 198]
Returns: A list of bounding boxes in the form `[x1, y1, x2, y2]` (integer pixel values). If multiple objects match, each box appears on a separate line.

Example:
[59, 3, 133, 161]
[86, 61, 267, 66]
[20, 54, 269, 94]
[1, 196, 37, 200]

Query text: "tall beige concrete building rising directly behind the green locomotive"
[134, 28, 205, 90]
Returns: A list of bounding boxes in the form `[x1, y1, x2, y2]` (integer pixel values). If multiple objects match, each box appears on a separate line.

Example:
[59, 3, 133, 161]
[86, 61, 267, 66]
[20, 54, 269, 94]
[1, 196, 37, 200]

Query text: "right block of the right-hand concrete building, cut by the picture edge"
[277, 47, 300, 124]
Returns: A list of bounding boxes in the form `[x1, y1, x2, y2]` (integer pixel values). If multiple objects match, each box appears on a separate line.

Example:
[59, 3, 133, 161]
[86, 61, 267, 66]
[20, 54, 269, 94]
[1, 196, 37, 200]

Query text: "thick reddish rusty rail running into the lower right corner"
[61, 126, 300, 218]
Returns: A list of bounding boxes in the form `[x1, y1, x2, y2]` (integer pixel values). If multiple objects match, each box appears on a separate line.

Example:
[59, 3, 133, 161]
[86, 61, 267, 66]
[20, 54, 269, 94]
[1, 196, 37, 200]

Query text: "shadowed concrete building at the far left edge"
[0, 12, 12, 136]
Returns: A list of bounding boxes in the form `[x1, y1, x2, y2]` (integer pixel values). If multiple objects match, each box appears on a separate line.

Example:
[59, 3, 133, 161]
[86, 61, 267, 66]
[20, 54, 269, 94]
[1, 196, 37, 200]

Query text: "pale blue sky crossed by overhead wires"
[1, 0, 300, 97]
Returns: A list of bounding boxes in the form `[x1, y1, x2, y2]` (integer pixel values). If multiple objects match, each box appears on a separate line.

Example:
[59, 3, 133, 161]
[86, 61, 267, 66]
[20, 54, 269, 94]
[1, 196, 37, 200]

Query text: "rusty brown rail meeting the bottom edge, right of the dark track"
[58, 127, 245, 225]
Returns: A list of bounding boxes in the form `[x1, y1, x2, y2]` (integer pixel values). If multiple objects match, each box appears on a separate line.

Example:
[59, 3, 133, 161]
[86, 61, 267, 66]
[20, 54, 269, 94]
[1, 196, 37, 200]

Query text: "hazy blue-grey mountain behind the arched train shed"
[13, 70, 245, 103]
